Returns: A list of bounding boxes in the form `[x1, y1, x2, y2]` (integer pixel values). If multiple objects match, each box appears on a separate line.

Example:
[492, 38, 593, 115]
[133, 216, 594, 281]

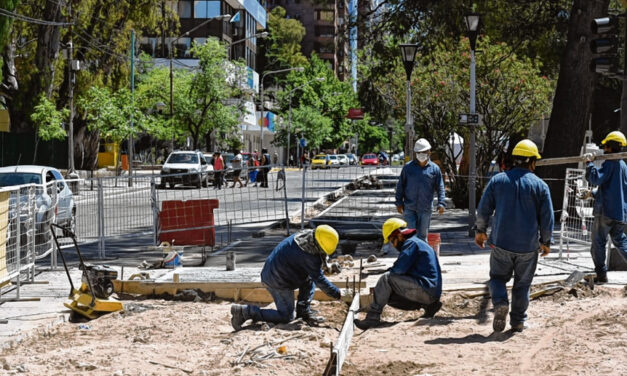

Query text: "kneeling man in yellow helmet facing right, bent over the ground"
[231, 225, 352, 330]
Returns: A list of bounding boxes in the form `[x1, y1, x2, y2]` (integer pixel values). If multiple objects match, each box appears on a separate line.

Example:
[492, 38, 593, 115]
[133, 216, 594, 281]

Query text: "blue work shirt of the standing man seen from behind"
[475, 167, 553, 253]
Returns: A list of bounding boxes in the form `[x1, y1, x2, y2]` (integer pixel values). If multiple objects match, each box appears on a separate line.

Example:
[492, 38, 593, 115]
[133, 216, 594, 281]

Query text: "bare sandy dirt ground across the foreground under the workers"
[0, 285, 627, 376]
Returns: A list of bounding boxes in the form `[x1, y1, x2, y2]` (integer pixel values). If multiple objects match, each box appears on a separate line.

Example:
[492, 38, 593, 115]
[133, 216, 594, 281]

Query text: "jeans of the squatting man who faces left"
[369, 272, 437, 315]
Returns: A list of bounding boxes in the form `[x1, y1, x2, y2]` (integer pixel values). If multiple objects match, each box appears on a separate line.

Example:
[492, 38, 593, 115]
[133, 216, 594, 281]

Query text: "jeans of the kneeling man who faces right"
[244, 278, 316, 324]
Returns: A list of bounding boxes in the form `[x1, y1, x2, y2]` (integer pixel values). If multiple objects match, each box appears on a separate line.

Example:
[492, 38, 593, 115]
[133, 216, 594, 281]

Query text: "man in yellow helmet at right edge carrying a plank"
[584, 131, 627, 283]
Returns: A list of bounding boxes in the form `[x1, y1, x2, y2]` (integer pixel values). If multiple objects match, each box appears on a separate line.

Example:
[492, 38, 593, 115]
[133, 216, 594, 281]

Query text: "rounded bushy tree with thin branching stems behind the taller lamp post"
[366, 37, 553, 194]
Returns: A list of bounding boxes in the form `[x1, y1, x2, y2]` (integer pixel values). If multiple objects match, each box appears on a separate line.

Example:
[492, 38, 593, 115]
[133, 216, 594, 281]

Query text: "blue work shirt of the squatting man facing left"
[390, 235, 442, 299]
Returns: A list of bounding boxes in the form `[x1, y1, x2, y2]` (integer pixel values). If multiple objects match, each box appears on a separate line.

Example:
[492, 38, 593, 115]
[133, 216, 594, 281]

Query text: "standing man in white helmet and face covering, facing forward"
[396, 138, 445, 240]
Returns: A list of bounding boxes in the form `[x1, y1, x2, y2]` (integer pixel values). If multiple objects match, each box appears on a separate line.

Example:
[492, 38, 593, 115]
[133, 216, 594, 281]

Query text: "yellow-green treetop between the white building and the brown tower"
[263, 7, 307, 70]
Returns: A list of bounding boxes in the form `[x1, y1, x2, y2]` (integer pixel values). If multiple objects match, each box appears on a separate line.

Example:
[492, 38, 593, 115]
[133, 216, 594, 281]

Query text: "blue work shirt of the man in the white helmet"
[396, 160, 446, 212]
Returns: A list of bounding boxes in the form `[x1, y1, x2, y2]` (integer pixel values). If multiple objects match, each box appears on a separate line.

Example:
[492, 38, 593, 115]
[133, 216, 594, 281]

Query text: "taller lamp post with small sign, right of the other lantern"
[464, 13, 479, 237]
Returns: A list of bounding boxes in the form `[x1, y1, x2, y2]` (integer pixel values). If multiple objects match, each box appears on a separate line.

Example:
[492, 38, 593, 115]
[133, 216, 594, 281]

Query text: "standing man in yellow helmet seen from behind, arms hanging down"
[475, 140, 553, 332]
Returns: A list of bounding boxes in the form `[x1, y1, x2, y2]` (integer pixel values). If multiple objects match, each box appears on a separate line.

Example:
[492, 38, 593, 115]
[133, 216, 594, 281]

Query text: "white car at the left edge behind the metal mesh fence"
[0, 166, 76, 234]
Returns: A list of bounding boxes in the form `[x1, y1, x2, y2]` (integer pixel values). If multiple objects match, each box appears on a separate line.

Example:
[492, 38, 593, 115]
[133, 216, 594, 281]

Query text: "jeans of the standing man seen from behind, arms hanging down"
[490, 247, 538, 325]
